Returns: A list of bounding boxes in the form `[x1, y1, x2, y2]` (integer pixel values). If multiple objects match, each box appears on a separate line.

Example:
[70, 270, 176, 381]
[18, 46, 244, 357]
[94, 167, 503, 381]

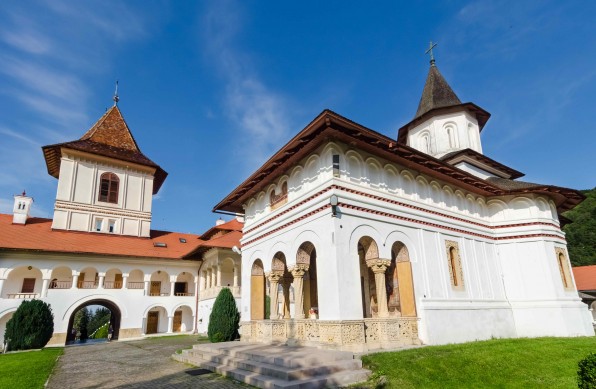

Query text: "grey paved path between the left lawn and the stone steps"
[47, 336, 249, 389]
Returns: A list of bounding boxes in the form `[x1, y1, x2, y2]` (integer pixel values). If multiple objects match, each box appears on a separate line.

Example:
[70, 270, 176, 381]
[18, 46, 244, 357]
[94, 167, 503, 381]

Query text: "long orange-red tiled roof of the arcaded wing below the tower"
[0, 214, 202, 259]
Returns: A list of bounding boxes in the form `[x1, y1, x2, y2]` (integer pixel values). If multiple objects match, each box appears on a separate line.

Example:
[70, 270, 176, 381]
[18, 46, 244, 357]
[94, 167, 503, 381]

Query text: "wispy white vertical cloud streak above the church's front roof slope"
[204, 0, 290, 169]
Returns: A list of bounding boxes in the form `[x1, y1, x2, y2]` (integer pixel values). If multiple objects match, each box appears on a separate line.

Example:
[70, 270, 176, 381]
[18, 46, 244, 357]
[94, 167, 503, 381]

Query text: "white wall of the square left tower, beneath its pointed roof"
[52, 153, 153, 237]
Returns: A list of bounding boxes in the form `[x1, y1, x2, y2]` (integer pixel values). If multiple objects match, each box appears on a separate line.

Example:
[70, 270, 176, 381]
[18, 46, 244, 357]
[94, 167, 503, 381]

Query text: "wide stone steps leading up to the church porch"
[173, 342, 370, 389]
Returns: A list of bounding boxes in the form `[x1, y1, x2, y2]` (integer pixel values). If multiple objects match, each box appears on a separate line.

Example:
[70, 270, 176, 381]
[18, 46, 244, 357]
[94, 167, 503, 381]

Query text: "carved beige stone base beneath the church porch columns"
[240, 317, 421, 352]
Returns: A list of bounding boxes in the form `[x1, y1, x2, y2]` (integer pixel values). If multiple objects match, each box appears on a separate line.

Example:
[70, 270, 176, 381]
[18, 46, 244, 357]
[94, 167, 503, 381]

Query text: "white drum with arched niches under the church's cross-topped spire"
[407, 111, 482, 158]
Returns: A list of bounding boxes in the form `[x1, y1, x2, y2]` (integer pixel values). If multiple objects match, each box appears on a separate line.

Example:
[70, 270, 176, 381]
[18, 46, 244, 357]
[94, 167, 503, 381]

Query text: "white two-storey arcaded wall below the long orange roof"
[0, 253, 199, 345]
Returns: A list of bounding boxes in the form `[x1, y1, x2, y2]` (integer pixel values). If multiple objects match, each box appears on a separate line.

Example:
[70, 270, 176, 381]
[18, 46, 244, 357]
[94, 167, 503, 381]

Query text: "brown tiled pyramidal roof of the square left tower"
[42, 106, 168, 194]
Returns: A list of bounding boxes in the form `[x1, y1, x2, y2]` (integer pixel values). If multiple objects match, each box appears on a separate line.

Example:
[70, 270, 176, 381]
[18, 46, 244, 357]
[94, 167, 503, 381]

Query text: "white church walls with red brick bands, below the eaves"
[241, 143, 593, 344]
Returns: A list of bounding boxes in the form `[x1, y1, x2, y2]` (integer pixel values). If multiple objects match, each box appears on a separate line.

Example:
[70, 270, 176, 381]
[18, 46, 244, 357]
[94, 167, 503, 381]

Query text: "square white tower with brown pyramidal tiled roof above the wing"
[42, 104, 167, 237]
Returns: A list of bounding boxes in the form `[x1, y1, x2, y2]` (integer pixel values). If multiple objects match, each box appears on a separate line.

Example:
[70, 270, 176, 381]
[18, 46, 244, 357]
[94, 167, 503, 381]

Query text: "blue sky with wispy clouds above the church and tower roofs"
[0, 0, 596, 233]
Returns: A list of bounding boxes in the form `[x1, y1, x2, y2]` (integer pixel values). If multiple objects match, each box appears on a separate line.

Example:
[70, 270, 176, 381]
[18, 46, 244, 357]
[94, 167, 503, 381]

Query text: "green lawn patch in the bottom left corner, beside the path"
[0, 348, 64, 389]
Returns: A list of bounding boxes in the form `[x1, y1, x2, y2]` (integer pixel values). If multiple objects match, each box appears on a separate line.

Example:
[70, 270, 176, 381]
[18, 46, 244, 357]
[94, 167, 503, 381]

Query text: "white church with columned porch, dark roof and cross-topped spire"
[214, 61, 594, 350]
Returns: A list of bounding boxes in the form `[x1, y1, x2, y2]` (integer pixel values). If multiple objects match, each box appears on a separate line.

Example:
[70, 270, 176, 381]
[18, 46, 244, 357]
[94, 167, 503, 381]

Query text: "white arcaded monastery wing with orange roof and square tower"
[0, 105, 242, 347]
